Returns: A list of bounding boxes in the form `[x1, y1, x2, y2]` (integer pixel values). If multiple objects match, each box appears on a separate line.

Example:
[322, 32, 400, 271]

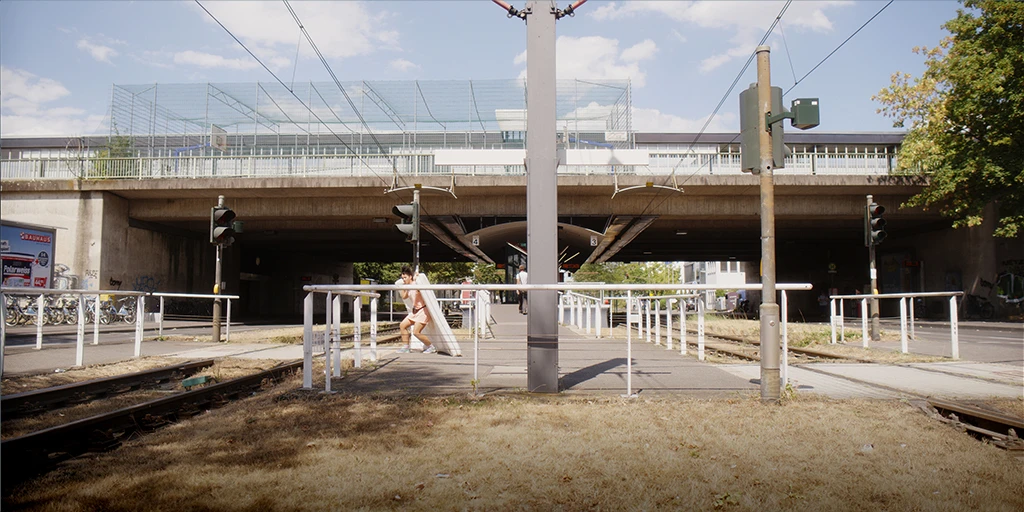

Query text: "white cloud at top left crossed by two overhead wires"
[195, 1, 398, 58]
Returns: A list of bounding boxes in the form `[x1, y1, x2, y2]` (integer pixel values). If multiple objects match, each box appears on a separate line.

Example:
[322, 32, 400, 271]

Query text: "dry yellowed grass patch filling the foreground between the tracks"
[3, 378, 1024, 512]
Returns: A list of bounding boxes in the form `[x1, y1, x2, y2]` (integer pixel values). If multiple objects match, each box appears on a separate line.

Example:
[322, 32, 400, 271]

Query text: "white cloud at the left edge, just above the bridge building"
[0, 67, 103, 137]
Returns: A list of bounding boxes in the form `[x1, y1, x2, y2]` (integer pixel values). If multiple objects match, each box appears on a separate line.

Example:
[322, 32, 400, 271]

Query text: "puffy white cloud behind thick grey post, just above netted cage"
[513, 36, 657, 87]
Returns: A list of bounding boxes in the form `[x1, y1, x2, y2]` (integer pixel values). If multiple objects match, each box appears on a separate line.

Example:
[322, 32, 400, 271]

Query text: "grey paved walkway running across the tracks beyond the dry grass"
[4, 305, 1024, 399]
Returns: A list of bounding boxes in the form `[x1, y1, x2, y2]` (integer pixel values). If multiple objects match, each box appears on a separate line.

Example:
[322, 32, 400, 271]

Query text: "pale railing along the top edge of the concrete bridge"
[6, 150, 895, 180]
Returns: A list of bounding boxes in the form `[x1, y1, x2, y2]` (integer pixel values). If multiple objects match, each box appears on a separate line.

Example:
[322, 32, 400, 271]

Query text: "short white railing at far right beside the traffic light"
[828, 292, 964, 359]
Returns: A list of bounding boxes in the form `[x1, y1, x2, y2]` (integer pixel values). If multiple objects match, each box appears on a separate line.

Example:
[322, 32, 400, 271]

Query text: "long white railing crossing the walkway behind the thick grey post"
[302, 283, 811, 396]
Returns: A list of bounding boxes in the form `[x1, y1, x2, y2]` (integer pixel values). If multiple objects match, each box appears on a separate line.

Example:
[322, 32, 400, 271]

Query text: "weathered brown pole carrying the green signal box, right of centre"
[757, 45, 781, 401]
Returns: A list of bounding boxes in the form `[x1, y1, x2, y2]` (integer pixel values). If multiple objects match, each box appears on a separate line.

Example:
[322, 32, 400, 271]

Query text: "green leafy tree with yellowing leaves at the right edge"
[873, 0, 1024, 238]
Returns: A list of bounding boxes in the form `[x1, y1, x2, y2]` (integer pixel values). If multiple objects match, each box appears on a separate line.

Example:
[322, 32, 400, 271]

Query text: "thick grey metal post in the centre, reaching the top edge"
[525, 0, 558, 393]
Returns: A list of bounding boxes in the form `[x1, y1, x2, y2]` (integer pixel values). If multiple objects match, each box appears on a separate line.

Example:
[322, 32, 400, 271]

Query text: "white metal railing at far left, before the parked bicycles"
[0, 287, 239, 375]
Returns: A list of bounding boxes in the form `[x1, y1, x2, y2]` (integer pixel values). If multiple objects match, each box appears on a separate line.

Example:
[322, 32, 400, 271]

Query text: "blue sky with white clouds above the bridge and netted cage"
[0, 0, 959, 136]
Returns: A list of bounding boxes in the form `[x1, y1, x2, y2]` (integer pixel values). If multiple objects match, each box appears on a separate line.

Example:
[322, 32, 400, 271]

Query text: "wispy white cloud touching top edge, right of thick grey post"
[590, 0, 853, 73]
